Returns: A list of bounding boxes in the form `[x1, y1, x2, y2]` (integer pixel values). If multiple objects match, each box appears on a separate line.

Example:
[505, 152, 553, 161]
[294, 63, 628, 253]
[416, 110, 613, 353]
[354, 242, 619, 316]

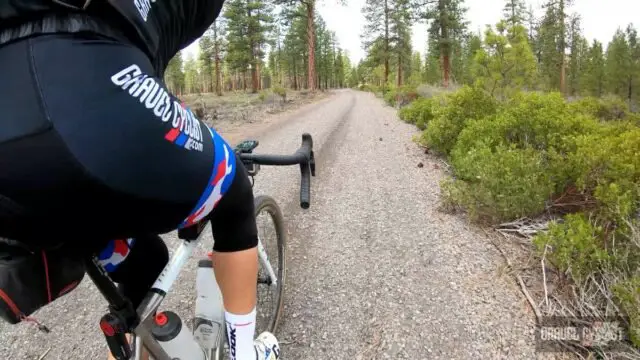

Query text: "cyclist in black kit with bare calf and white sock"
[0, 0, 279, 360]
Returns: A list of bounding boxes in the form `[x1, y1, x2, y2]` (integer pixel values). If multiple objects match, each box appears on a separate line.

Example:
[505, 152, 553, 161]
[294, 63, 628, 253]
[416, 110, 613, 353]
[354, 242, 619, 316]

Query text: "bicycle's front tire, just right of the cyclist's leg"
[254, 195, 287, 334]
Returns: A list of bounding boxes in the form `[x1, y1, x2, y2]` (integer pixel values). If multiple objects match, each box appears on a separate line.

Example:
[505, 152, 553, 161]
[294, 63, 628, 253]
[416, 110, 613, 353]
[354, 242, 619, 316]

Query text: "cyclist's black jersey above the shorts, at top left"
[0, 0, 224, 75]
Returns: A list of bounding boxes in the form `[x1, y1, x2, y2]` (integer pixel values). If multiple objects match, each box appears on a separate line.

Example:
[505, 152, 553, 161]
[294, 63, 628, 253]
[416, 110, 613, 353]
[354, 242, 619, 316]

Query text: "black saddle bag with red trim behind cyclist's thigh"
[0, 239, 85, 324]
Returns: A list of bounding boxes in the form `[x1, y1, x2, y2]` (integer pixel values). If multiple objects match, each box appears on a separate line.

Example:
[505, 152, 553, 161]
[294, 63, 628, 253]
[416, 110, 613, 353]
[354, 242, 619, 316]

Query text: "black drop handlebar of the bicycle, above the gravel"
[240, 133, 316, 209]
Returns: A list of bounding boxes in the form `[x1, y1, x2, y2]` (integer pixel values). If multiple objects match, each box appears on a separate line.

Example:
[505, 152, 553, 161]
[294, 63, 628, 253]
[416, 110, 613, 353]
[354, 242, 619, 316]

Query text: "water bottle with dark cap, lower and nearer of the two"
[151, 311, 207, 360]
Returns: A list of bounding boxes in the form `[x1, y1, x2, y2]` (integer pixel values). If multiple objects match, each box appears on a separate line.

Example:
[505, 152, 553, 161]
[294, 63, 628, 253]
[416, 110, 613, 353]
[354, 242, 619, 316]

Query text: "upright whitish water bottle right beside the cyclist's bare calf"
[193, 260, 225, 351]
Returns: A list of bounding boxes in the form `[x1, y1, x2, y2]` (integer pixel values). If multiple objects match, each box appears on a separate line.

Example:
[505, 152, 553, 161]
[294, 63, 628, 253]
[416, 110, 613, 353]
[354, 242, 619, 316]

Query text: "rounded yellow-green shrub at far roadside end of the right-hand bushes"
[422, 86, 498, 155]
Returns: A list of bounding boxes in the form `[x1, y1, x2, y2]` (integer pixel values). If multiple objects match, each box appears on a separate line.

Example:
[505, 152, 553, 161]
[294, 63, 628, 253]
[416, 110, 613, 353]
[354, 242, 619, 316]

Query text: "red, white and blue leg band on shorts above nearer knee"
[179, 127, 236, 228]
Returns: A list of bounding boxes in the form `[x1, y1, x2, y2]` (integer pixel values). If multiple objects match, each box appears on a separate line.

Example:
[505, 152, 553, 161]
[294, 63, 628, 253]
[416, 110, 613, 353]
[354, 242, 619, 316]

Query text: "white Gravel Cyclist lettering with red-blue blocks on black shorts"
[111, 64, 202, 152]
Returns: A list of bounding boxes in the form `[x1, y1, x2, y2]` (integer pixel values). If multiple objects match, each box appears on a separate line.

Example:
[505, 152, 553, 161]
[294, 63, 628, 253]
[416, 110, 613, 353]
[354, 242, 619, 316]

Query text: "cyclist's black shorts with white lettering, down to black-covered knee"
[0, 33, 257, 252]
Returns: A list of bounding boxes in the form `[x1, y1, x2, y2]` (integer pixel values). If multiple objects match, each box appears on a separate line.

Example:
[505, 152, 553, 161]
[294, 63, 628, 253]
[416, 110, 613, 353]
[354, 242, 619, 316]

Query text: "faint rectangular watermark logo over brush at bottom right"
[535, 316, 629, 352]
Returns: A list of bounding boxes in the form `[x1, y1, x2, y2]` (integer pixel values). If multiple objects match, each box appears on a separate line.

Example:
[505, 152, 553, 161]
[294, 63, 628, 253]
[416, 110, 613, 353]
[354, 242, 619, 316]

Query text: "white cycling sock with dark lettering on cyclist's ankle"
[224, 308, 256, 360]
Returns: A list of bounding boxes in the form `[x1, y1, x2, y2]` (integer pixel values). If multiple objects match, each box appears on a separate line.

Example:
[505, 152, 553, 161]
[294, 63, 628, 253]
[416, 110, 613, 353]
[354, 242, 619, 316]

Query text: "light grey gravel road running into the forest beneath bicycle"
[0, 90, 536, 360]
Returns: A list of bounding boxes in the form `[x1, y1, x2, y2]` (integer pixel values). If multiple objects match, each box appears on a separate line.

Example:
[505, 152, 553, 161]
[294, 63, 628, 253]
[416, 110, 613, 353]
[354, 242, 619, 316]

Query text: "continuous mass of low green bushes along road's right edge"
[400, 87, 640, 347]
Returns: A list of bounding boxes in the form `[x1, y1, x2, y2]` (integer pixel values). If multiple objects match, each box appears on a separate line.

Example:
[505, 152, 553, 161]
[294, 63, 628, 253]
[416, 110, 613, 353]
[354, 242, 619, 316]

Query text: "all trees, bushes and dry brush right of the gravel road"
[355, 0, 640, 359]
